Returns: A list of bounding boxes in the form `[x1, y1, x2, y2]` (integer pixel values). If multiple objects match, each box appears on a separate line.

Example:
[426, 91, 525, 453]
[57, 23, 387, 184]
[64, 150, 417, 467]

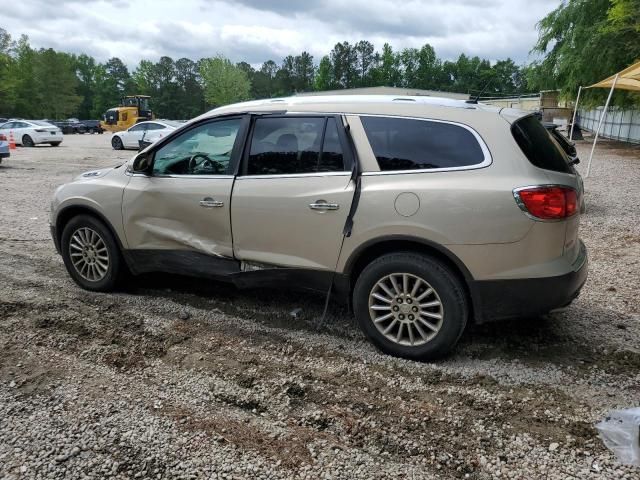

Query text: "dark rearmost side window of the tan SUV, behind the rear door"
[361, 117, 485, 171]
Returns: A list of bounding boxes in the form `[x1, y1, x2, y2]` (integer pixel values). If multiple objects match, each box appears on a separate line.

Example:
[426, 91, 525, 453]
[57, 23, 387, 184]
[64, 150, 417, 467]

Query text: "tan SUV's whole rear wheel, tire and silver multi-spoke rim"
[353, 252, 469, 360]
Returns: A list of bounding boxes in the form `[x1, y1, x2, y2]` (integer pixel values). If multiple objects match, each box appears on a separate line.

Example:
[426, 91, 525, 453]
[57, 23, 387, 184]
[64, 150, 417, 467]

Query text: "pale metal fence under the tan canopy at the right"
[576, 107, 640, 143]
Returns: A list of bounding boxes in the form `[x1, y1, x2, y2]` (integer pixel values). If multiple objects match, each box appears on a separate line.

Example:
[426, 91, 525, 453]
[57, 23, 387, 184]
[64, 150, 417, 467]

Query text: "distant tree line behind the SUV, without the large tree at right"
[0, 29, 527, 119]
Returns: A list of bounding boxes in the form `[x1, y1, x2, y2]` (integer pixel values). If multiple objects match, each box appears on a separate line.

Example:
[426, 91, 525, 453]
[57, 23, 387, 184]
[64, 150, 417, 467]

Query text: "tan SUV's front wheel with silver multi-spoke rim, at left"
[60, 215, 125, 292]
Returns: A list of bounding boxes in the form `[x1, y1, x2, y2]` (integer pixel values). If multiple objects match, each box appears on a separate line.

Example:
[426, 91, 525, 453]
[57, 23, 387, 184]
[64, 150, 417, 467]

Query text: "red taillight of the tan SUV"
[513, 186, 578, 220]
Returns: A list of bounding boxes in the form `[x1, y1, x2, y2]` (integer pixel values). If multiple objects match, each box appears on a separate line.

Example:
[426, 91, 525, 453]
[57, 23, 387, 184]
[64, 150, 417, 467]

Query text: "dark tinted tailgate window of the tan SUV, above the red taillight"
[511, 116, 571, 173]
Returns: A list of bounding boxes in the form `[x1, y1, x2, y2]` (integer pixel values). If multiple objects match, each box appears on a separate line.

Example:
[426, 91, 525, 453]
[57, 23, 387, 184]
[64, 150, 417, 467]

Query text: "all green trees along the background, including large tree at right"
[0, 0, 640, 119]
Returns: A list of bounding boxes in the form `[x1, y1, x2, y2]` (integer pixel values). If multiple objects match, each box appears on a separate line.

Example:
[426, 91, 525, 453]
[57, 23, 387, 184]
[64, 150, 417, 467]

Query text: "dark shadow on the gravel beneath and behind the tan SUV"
[125, 274, 640, 368]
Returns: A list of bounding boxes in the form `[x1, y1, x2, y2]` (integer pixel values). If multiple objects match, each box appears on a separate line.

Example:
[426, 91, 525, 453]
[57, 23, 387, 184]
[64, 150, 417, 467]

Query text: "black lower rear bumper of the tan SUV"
[472, 241, 588, 323]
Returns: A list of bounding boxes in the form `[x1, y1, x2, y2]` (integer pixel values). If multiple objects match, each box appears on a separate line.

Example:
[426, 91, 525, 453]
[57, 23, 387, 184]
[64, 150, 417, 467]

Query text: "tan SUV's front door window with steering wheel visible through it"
[152, 118, 242, 175]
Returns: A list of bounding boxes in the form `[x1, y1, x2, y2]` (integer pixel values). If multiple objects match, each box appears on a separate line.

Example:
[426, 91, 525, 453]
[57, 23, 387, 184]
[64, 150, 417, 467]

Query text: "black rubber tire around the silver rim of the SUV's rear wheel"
[353, 252, 469, 360]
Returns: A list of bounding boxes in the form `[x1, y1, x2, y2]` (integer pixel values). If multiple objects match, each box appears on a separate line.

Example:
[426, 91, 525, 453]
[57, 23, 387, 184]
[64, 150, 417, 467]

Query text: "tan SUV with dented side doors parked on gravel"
[51, 95, 587, 359]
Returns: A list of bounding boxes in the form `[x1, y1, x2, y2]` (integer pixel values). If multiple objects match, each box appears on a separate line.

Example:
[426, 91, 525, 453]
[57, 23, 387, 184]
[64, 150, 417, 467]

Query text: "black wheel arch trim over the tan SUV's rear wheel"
[343, 235, 477, 318]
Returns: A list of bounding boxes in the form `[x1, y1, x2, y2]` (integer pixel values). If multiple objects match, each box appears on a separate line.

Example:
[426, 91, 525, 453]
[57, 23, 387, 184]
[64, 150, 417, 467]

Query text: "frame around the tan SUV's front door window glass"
[146, 114, 249, 180]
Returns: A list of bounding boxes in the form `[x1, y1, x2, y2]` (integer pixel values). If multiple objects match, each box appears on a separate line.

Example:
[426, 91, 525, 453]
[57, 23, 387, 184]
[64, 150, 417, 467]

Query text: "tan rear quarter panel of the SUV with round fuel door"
[339, 112, 564, 278]
